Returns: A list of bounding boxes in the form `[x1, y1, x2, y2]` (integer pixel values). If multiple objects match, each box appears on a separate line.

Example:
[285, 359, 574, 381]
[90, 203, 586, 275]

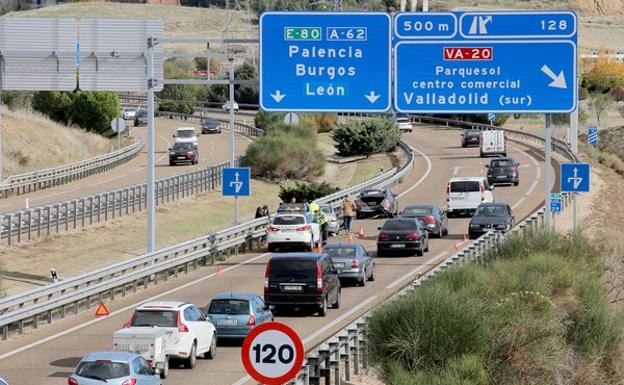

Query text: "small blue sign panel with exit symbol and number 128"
[459, 11, 577, 41]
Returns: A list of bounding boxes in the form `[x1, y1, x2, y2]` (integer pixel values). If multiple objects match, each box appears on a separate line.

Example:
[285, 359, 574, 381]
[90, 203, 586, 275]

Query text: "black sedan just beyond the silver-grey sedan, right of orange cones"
[377, 218, 429, 257]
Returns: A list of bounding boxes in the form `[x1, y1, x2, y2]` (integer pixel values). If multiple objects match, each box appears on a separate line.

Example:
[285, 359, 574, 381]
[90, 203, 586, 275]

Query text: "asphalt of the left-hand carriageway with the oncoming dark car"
[0, 118, 251, 213]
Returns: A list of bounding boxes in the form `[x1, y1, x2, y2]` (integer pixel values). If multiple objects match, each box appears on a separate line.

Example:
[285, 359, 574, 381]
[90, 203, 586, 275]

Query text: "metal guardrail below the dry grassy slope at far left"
[0, 139, 143, 198]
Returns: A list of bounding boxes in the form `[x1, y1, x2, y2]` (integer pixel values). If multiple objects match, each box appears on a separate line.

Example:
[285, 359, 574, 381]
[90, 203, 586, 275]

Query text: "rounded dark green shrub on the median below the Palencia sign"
[332, 119, 400, 156]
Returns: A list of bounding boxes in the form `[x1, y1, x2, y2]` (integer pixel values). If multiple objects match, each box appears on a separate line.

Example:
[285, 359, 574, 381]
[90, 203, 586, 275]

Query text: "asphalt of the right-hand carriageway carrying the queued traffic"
[0, 126, 556, 385]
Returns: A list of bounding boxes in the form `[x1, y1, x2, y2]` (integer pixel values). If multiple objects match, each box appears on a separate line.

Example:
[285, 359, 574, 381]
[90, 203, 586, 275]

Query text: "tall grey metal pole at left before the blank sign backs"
[146, 36, 156, 253]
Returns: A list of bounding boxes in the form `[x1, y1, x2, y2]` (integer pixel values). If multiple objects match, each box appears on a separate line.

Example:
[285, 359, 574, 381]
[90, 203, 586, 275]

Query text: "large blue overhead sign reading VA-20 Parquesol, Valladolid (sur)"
[394, 40, 577, 113]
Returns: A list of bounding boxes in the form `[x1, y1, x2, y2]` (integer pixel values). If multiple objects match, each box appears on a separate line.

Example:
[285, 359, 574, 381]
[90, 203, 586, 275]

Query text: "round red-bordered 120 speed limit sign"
[241, 322, 304, 385]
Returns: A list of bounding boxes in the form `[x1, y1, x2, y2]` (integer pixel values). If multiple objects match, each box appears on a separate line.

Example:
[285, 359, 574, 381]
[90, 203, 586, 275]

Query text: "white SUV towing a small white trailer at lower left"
[124, 301, 217, 369]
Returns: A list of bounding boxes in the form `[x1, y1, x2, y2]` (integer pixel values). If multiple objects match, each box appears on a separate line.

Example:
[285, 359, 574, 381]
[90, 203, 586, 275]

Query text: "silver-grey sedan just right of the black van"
[323, 243, 375, 286]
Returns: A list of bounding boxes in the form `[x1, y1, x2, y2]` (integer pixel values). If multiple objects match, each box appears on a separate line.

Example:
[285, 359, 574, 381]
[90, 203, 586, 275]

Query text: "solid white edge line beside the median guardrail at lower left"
[0, 253, 273, 360]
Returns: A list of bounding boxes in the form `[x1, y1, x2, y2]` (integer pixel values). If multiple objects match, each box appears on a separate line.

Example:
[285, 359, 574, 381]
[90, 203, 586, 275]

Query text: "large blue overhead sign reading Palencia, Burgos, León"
[260, 12, 391, 112]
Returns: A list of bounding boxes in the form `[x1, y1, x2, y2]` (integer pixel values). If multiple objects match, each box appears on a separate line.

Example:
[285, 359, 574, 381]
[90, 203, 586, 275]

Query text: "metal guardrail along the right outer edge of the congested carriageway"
[289, 116, 579, 385]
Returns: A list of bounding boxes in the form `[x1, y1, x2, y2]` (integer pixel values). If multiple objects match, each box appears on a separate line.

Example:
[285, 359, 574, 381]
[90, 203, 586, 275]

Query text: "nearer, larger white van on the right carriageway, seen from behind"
[446, 176, 494, 217]
